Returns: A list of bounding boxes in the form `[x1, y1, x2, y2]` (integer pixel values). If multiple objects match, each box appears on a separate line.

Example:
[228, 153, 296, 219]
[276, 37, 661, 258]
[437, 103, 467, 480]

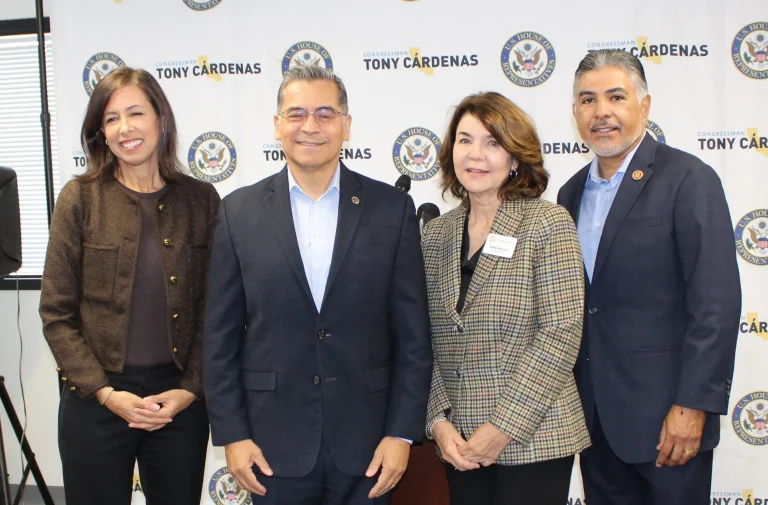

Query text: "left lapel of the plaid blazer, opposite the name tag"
[439, 205, 467, 324]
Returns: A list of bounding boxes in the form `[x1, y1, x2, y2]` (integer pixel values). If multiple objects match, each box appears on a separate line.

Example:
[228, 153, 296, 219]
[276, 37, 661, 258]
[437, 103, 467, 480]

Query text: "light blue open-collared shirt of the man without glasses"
[578, 136, 642, 282]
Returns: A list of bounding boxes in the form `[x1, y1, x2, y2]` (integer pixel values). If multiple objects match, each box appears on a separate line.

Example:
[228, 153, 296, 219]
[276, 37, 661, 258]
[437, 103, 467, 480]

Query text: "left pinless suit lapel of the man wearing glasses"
[266, 166, 315, 307]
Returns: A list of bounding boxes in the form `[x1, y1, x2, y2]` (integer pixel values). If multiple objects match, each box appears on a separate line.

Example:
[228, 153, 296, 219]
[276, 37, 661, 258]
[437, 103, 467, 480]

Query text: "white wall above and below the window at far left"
[0, 0, 62, 486]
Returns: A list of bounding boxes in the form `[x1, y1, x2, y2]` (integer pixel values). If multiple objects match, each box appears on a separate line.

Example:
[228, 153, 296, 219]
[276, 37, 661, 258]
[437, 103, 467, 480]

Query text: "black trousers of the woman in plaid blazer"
[445, 456, 572, 505]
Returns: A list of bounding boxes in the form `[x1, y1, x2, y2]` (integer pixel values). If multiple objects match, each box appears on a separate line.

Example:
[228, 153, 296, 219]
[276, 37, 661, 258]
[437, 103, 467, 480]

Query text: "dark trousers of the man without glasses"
[581, 412, 713, 505]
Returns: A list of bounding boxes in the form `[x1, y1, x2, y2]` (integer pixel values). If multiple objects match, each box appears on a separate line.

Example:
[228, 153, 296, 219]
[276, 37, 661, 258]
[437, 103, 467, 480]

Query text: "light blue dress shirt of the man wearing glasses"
[288, 165, 341, 312]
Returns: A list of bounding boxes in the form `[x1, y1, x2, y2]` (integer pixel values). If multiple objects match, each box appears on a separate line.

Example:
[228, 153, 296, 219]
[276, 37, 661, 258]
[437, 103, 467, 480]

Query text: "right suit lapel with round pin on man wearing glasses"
[323, 163, 366, 304]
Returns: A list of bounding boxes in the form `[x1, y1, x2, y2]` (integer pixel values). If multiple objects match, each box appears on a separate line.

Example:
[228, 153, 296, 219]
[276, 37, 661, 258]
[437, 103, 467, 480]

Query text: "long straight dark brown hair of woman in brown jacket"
[77, 67, 185, 182]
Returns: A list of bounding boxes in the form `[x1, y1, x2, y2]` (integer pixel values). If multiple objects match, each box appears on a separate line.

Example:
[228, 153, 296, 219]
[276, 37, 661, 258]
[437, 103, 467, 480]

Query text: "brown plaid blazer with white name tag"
[422, 198, 590, 465]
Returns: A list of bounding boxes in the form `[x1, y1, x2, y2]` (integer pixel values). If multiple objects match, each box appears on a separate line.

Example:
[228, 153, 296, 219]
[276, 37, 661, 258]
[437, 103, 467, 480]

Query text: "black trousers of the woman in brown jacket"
[59, 364, 208, 505]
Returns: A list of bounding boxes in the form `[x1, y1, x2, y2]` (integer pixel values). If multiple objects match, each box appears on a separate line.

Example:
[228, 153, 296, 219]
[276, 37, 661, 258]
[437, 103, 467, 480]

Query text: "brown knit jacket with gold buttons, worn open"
[40, 177, 220, 398]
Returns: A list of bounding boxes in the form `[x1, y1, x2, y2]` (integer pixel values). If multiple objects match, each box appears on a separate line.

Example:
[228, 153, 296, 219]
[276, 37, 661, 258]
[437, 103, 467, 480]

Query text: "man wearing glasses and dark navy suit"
[203, 66, 432, 505]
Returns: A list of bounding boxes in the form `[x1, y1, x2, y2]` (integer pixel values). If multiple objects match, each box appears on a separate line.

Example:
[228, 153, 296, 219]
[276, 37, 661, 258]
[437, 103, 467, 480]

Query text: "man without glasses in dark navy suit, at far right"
[558, 50, 741, 505]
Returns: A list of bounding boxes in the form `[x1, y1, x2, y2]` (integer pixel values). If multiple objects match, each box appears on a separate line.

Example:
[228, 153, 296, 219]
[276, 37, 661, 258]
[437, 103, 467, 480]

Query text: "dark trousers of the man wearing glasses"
[251, 428, 390, 505]
